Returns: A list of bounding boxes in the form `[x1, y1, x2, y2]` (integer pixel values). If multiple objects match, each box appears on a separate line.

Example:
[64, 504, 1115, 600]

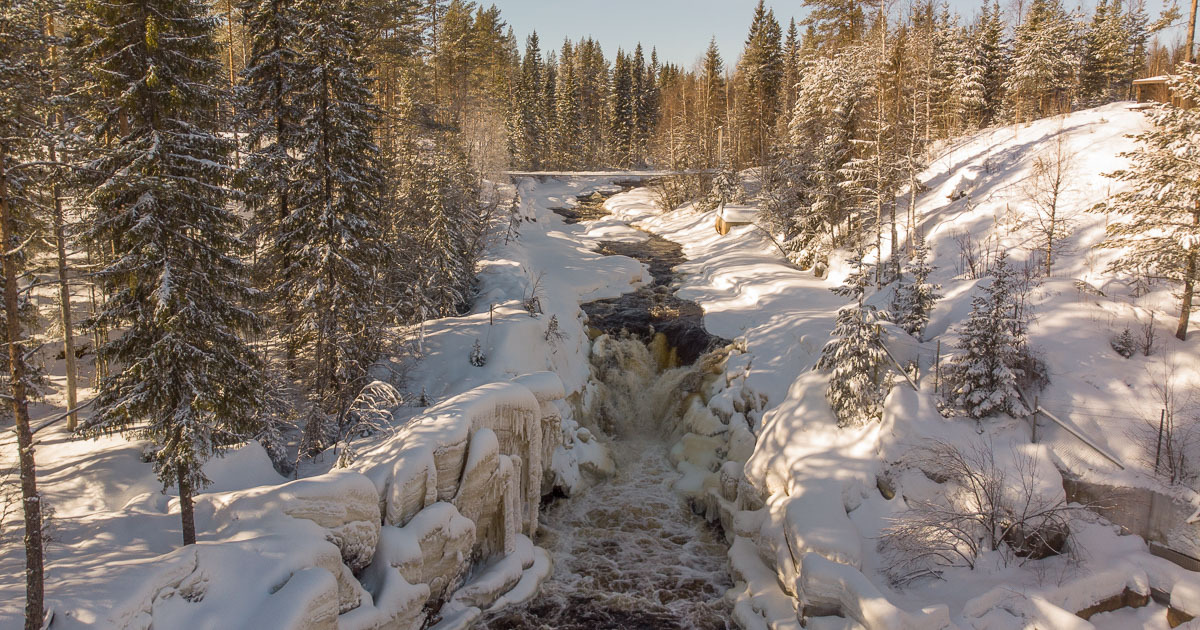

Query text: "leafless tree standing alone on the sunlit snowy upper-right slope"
[1026, 130, 1074, 277]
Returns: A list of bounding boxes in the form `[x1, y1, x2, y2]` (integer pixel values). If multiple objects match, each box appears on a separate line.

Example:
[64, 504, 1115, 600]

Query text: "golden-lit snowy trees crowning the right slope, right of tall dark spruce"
[763, 0, 1177, 272]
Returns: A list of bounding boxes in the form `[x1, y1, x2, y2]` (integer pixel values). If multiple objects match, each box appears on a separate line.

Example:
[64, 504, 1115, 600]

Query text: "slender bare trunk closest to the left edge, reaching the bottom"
[0, 145, 46, 630]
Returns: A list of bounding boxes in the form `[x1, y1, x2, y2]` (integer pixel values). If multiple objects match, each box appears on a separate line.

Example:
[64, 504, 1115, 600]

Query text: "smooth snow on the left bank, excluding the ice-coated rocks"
[0, 178, 647, 628]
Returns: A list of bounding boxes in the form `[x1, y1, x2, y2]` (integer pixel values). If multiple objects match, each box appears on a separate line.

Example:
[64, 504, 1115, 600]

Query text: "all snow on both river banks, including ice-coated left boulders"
[9, 103, 1200, 629]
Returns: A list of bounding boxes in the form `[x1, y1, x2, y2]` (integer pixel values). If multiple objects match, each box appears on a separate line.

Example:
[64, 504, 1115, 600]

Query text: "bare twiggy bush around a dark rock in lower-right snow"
[880, 442, 1076, 584]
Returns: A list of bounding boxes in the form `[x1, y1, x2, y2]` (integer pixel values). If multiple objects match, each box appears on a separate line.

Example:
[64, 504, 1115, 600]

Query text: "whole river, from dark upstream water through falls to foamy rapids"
[481, 186, 732, 630]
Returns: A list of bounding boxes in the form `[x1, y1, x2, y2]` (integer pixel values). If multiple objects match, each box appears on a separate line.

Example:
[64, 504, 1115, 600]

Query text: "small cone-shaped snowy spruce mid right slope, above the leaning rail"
[947, 252, 1028, 419]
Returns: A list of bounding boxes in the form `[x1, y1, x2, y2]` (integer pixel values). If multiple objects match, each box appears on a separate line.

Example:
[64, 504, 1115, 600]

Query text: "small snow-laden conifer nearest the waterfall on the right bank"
[817, 251, 890, 427]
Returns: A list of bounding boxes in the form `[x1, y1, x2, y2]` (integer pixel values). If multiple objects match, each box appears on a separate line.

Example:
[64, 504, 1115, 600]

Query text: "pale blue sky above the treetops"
[482, 0, 1190, 67]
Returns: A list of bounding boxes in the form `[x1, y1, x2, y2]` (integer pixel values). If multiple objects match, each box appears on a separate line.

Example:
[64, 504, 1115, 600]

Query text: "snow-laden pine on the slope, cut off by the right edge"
[1098, 64, 1200, 340]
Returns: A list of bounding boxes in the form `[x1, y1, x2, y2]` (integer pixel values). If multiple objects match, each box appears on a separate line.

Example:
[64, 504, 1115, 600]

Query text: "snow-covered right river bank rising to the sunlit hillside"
[608, 103, 1200, 628]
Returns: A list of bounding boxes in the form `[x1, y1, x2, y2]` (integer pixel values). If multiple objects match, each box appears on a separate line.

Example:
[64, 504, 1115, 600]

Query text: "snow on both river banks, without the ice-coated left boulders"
[0, 103, 1200, 629]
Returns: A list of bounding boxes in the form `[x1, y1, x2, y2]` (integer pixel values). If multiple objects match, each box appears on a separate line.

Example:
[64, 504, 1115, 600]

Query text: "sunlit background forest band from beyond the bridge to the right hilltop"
[508, 0, 1182, 204]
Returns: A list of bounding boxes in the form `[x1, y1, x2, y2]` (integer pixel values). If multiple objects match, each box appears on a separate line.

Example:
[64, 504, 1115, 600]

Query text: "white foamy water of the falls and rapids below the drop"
[481, 340, 732, 630]
